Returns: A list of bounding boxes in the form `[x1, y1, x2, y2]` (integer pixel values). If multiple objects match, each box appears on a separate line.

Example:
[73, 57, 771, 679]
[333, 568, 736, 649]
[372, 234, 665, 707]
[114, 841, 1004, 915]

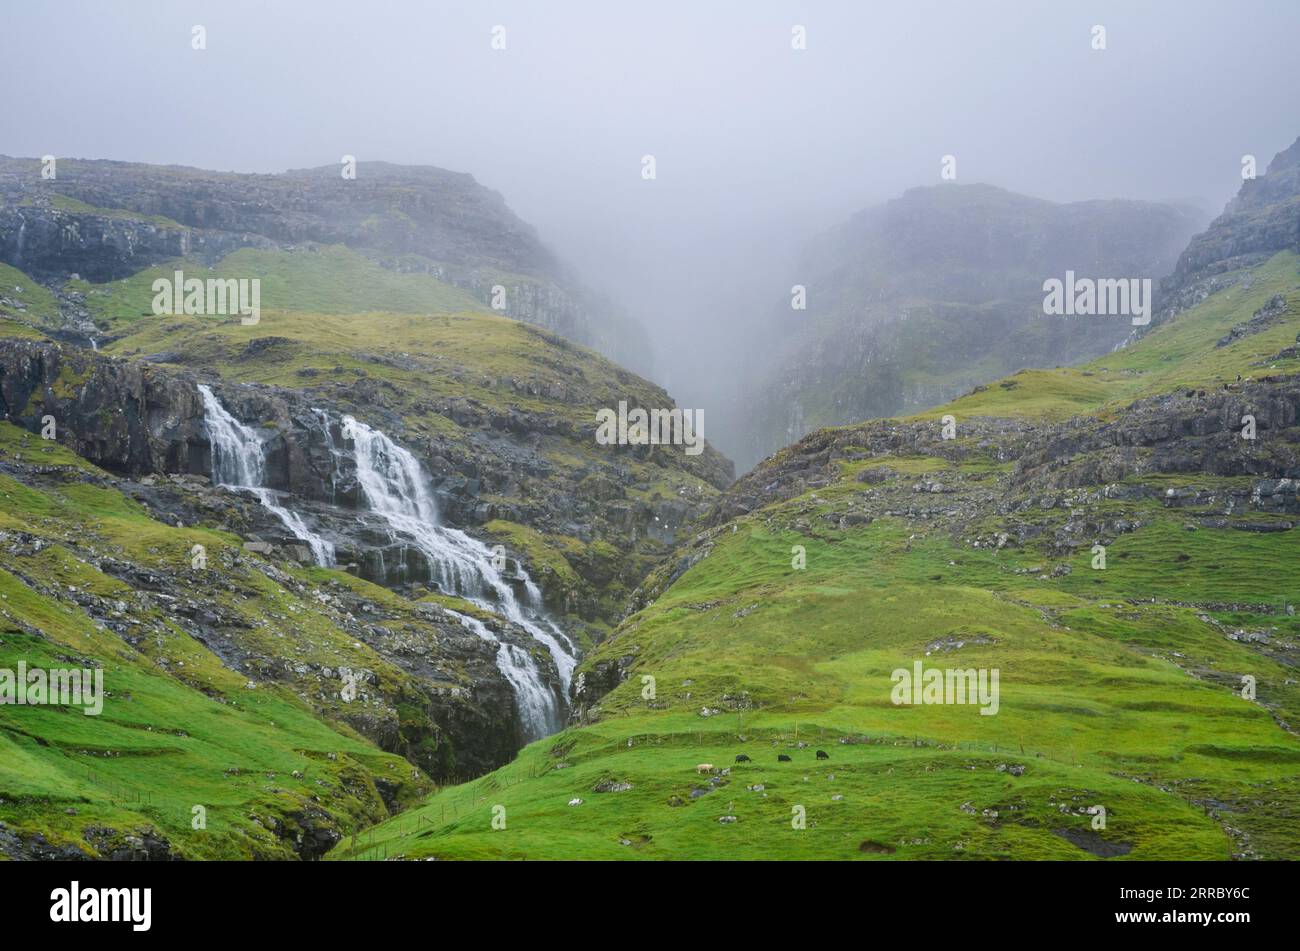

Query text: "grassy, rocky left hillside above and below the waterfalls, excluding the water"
[0, 239, 731, 859]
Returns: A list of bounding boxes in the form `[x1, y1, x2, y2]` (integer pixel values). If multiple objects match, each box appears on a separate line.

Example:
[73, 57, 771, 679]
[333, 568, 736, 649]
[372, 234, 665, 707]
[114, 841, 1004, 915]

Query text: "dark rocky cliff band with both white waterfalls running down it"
[0, 340, 579, 778]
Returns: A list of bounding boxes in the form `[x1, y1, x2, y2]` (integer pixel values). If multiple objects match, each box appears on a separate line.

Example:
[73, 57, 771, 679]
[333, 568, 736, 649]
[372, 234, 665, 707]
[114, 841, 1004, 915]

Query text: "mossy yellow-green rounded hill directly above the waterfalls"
[0, 246, 731, 639]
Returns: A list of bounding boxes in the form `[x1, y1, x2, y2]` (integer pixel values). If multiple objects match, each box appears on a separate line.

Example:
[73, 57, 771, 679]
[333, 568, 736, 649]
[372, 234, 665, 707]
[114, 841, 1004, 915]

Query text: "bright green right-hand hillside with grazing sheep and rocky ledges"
[332, 252, 1300, 860]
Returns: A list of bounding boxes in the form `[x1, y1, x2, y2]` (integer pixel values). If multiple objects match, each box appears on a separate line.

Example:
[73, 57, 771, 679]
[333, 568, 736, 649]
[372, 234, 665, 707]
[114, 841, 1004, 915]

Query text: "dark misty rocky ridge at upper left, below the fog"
[0, 156, 650, 372]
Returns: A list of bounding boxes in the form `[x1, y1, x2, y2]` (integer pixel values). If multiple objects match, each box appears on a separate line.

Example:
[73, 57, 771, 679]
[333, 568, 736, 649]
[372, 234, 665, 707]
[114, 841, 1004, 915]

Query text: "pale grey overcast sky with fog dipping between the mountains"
[0, 0, 1300, 403]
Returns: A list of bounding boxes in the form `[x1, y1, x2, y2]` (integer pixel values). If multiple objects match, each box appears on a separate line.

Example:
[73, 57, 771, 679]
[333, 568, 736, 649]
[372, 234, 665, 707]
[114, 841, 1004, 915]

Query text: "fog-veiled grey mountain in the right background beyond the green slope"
[738, 184, 1201, 465]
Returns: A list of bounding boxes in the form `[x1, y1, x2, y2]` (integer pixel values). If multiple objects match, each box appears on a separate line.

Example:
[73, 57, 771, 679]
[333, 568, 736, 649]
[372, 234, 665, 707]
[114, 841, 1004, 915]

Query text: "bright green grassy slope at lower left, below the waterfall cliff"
[0, 424, 430, 859]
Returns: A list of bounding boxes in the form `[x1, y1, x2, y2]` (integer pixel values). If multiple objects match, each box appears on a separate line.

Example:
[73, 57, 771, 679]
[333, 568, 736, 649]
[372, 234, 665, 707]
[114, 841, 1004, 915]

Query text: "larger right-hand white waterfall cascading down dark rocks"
[342, 416, 577, 739]
